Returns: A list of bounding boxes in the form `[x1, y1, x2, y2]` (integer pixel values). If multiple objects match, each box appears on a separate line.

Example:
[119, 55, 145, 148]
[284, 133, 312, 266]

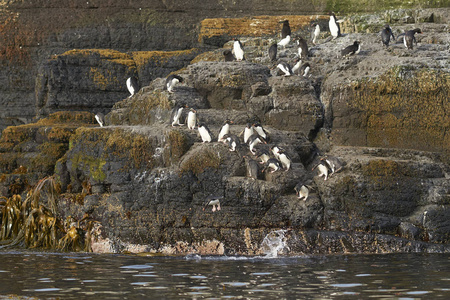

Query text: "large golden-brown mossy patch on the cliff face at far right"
[347, 67, 450, 151]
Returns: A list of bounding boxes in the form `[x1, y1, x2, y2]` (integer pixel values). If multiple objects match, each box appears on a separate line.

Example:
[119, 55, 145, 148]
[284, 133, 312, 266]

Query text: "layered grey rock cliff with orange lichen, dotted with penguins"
[0, 1, 450, 254]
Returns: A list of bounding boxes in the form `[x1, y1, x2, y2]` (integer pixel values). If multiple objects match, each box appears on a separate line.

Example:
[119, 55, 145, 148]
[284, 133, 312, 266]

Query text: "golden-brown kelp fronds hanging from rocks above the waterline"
[0, 176, 95, 252]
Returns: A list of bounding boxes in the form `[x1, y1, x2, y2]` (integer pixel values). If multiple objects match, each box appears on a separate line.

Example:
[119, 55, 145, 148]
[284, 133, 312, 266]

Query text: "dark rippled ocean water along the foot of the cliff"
[0, 252, 450, 299]
